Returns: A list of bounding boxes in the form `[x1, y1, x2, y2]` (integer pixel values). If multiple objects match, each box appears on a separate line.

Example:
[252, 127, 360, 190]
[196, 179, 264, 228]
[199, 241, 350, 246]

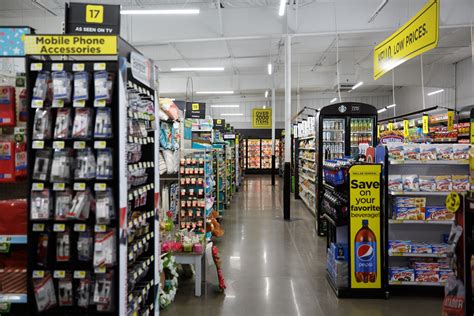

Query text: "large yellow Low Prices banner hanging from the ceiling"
[374, 0, 440, 80]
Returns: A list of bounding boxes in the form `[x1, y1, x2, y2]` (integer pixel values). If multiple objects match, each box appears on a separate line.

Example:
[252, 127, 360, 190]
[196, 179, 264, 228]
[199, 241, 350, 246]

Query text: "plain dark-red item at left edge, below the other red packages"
[0, 199, 28, 235]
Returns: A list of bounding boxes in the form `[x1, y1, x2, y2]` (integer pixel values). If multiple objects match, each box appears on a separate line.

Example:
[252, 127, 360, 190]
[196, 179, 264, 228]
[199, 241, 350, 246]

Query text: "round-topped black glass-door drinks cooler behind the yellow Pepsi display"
[316, 102, 377, 235]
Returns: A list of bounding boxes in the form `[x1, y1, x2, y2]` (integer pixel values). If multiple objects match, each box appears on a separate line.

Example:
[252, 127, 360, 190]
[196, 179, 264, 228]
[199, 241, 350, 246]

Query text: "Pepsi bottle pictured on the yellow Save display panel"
[354, 219, 377, 283]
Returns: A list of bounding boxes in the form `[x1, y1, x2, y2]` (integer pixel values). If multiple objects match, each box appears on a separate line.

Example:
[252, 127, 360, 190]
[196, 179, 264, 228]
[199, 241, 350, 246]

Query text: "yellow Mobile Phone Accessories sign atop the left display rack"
[25, 35, 117, 55]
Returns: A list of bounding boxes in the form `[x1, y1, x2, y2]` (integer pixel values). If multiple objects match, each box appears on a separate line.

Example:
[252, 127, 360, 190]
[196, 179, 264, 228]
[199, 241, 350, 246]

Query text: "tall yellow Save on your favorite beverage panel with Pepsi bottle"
[349, 164, 382, 289]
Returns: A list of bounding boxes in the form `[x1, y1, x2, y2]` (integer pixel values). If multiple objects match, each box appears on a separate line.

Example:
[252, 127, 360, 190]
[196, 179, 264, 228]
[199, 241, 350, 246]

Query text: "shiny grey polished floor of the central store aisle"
[161, 176, 442, 316]
